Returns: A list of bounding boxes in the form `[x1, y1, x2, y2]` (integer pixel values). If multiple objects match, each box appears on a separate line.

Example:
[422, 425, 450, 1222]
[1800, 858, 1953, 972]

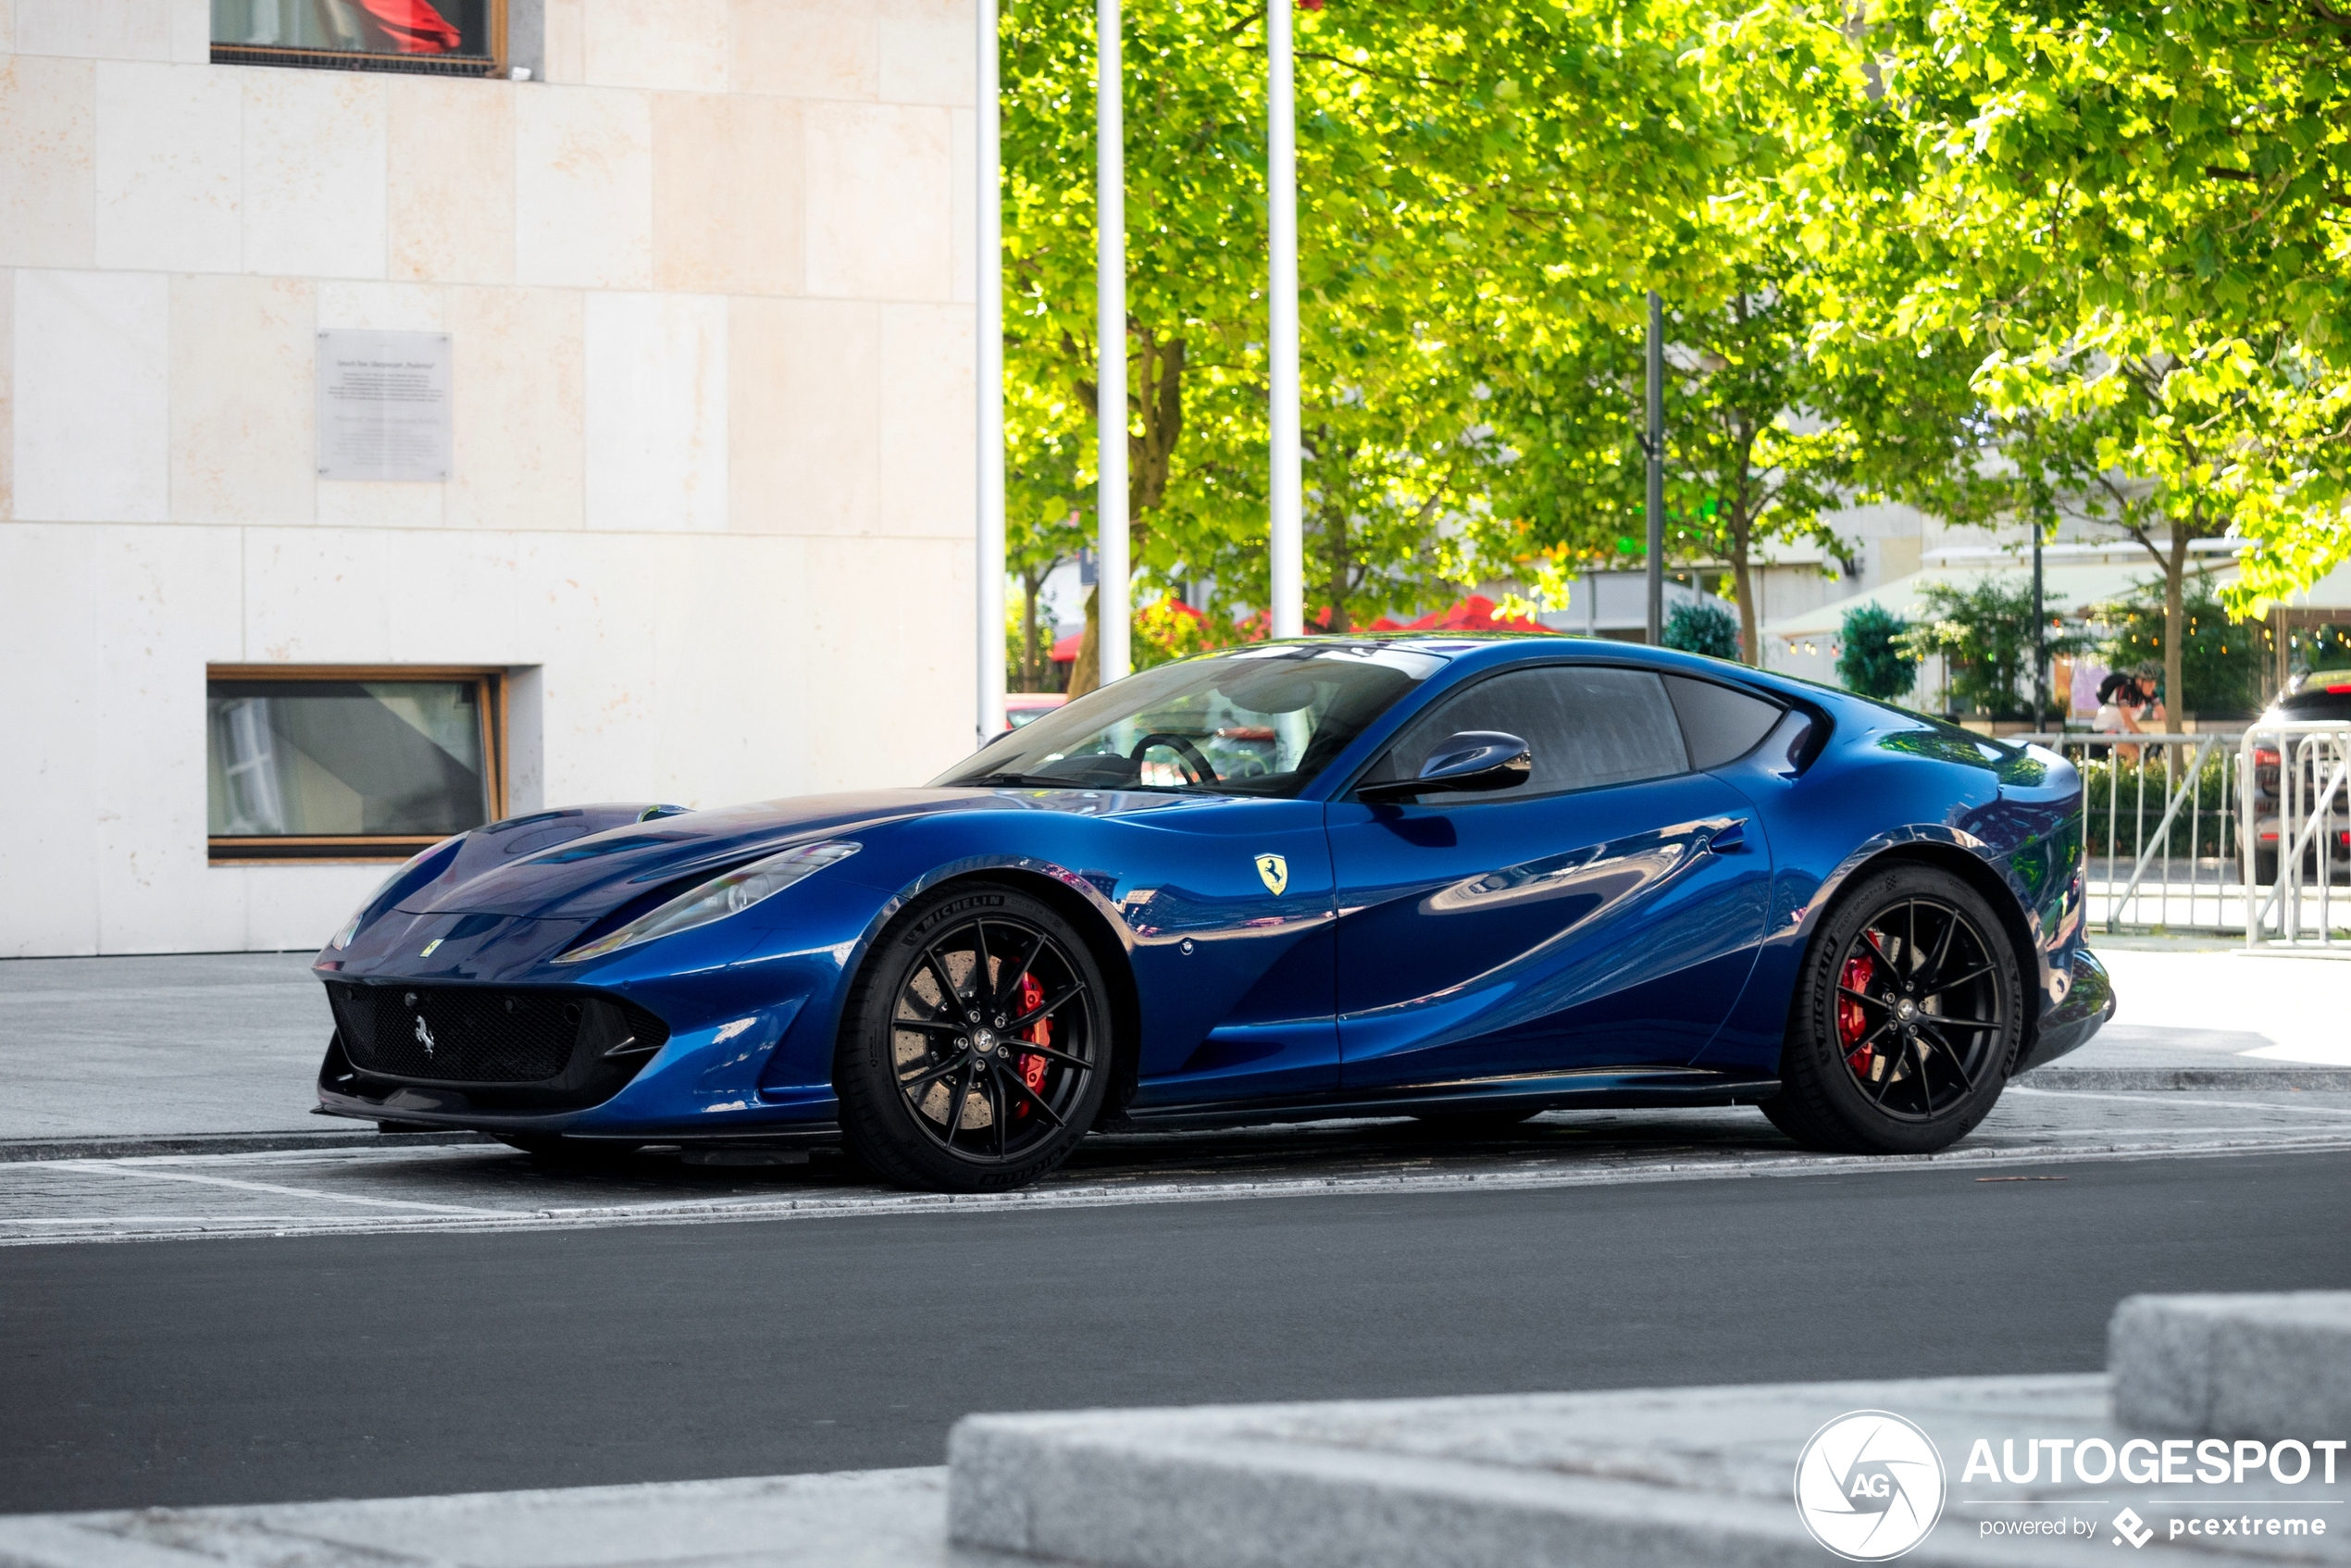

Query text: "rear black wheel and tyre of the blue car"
[1763, 863, 2024, 1154]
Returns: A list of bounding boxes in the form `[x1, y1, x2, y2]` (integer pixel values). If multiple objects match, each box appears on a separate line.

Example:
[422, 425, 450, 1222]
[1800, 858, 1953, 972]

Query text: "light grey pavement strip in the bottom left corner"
[0, 1469, 1006, 1568]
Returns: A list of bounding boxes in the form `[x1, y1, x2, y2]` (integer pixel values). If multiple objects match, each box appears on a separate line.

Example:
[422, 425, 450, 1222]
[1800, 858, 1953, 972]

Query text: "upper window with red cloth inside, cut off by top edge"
[212, 0, 508, 75]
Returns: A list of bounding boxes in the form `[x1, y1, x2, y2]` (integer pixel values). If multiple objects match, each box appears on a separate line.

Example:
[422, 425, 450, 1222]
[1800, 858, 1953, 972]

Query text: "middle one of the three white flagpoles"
[1093, 0, 1133, 687]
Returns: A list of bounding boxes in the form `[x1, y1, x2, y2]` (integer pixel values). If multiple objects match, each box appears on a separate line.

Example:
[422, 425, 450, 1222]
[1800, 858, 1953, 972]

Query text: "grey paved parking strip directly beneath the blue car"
[0, 1089, 2351, 1246]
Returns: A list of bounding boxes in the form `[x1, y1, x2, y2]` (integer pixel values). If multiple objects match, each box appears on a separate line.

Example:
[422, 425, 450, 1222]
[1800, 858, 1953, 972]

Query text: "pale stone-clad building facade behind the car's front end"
[0, 0, 974, 954]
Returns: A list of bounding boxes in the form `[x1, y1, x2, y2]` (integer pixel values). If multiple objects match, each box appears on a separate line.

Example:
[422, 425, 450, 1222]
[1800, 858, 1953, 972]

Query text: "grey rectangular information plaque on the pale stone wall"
[317, 327, 449, 484]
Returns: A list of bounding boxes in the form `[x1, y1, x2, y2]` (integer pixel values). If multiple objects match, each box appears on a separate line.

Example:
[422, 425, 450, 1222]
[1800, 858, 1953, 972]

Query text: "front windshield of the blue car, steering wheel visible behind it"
[931, 644, 1444, 794]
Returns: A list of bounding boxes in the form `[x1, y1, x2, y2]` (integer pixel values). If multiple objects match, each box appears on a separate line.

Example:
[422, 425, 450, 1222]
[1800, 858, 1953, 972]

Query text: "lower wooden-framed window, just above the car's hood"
[205, 666, 505, 865]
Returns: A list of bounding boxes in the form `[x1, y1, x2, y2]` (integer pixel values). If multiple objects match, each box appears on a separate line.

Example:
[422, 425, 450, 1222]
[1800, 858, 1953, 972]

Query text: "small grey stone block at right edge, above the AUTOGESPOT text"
[2107, 1290, 2351, 1438]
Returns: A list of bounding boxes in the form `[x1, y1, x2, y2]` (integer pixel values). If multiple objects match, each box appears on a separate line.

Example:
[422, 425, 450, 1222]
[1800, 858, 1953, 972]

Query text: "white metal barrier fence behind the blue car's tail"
[2008, 724, 2351, 945]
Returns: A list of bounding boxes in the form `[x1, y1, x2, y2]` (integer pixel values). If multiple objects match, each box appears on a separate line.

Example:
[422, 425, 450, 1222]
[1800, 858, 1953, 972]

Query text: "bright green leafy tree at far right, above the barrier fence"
[1768, 0, 2351, 709]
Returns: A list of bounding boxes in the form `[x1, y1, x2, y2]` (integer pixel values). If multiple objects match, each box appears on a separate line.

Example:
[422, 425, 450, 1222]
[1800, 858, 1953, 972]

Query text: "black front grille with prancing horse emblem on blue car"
[327, 980, 670, 1084]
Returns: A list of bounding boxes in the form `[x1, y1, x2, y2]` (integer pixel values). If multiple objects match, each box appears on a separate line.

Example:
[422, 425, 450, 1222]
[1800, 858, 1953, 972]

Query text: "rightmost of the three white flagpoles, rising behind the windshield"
[1265, 0, 1307, 637]
